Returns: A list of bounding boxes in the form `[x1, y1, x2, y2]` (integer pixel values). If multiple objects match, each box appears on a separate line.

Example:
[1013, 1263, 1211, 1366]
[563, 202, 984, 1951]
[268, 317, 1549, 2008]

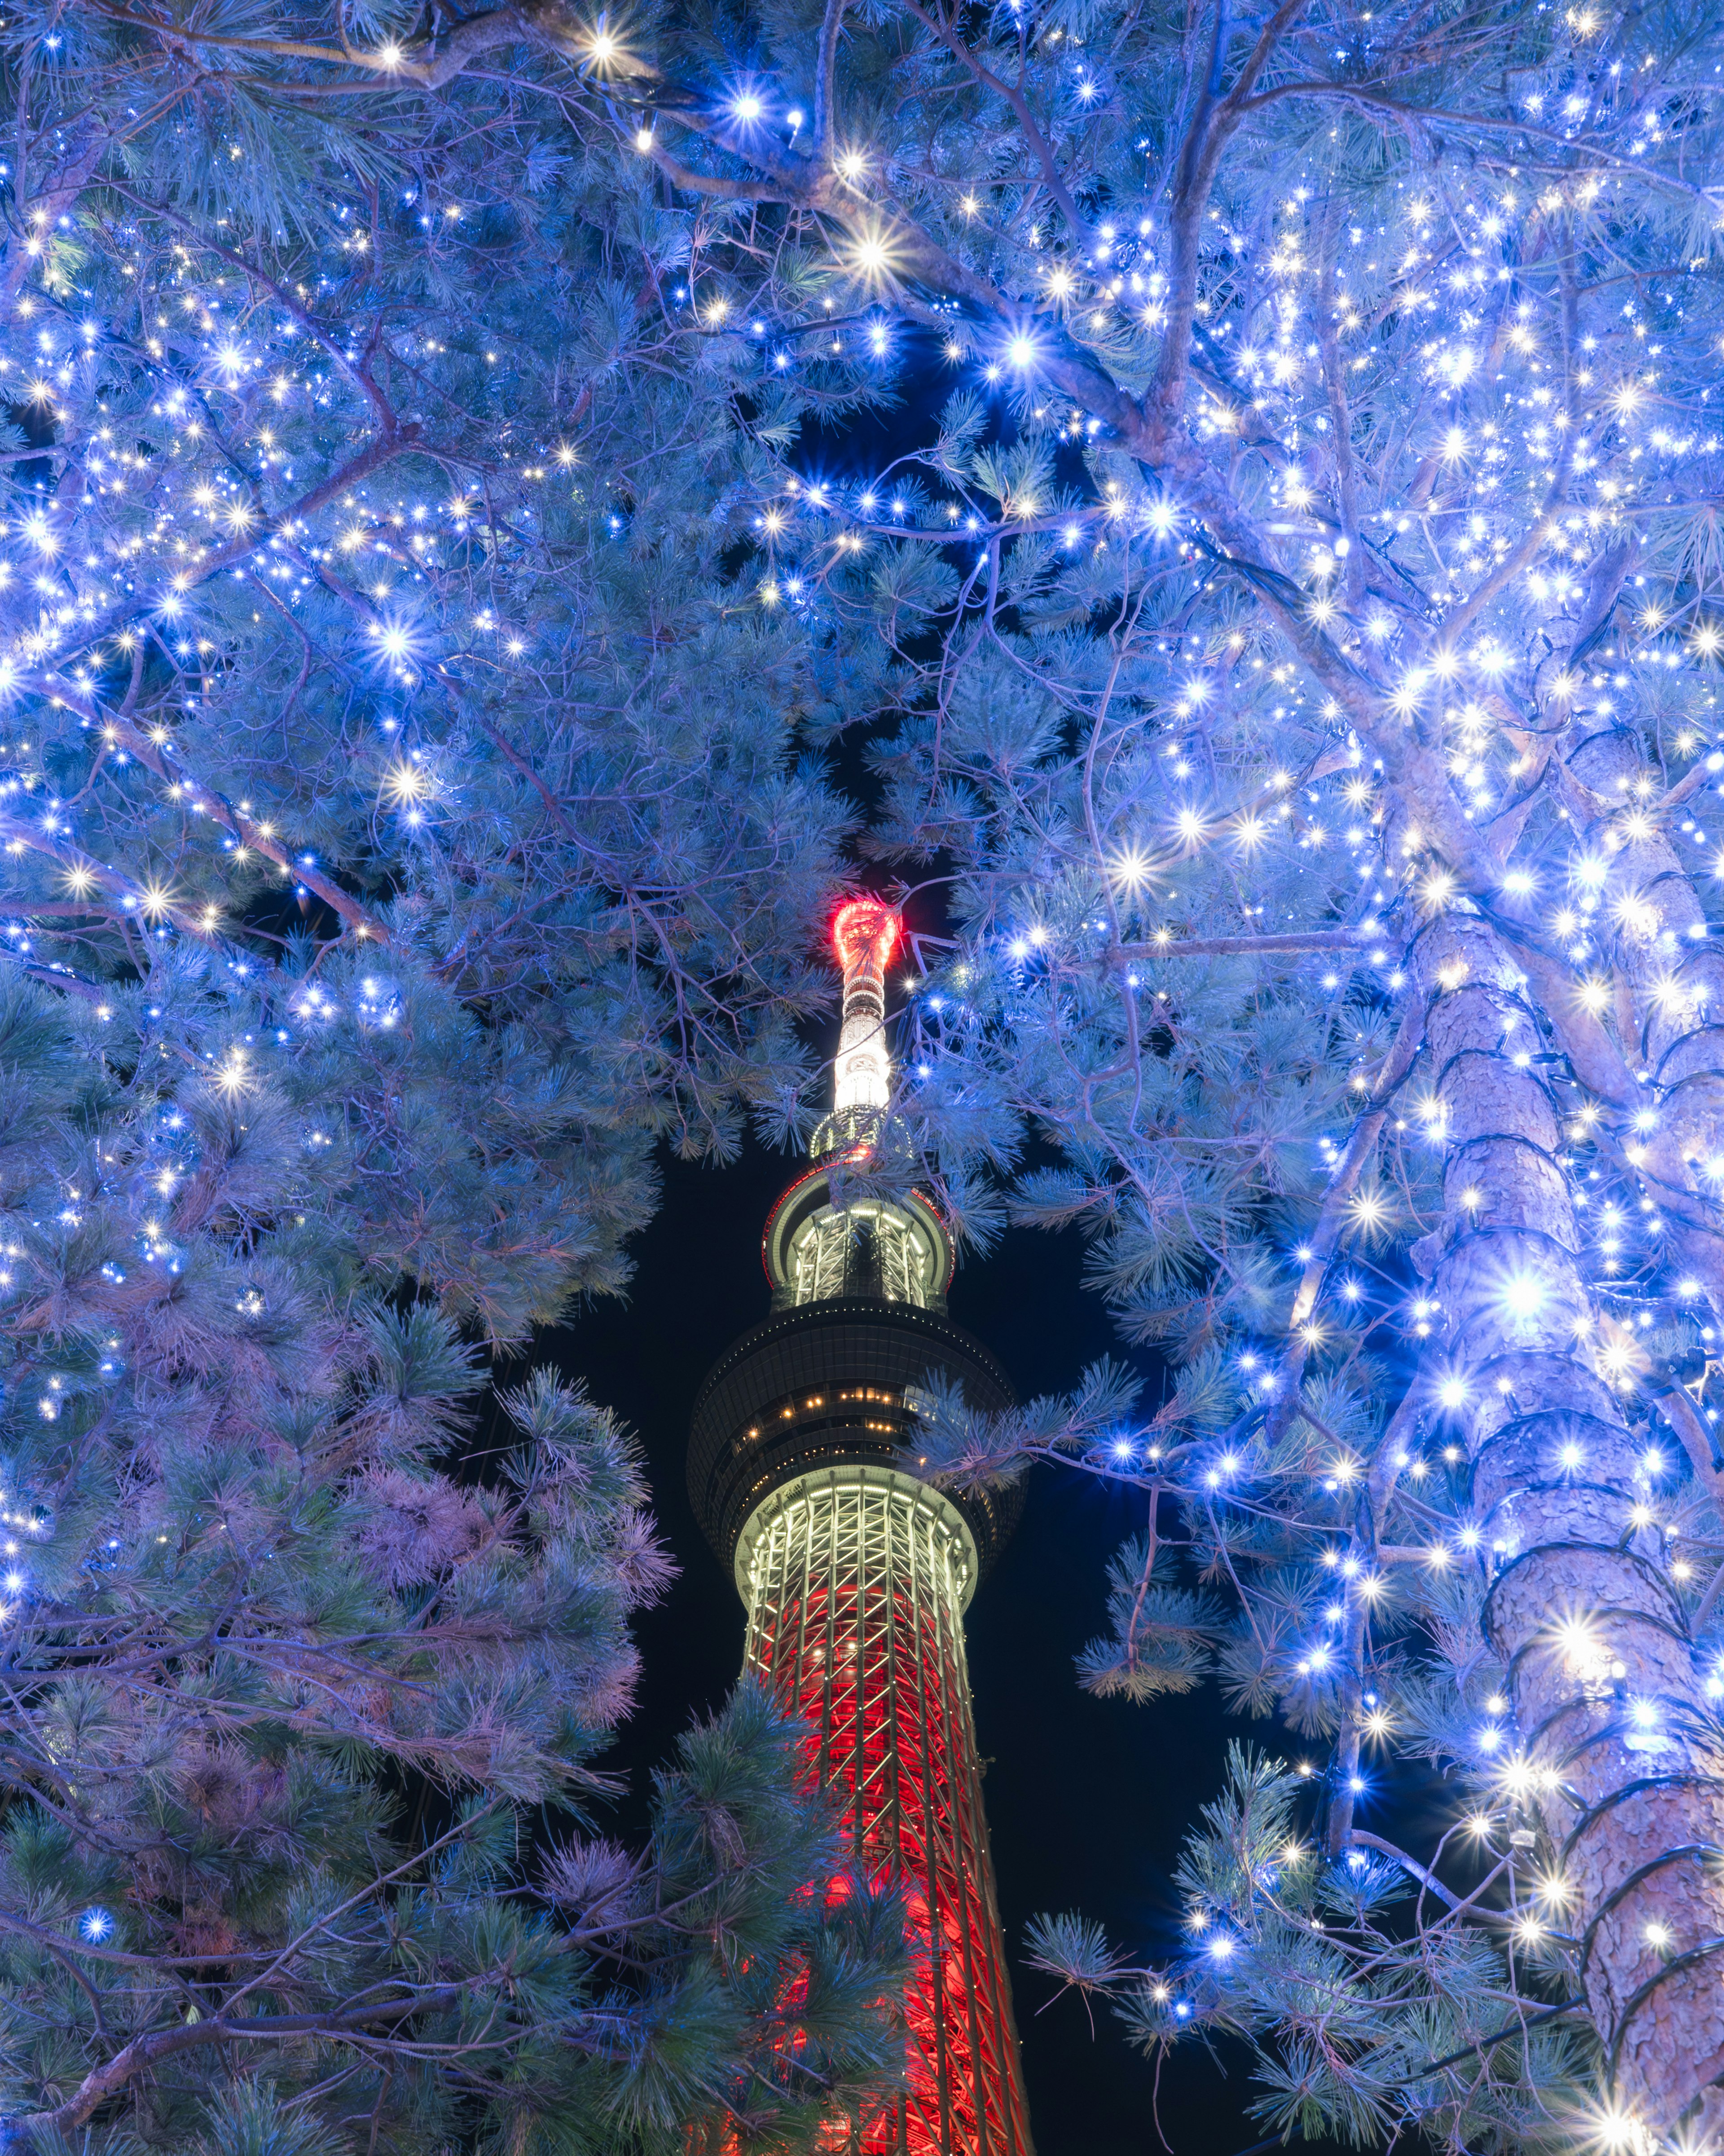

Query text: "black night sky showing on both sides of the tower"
[541, 1147, 1370, 2156]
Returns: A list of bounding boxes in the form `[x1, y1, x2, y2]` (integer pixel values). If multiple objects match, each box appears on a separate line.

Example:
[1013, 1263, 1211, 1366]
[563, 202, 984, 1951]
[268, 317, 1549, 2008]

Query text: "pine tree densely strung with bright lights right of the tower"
[465, 0, 1724, 2145]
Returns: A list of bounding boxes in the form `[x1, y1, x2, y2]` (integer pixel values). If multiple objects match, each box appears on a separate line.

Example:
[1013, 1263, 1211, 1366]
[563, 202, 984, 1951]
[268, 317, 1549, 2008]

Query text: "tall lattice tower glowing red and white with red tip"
[690, 899, 1030, 2156]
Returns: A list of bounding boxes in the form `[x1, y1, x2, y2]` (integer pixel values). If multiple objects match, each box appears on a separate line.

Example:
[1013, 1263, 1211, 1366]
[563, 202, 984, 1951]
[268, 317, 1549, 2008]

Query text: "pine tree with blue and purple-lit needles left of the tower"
[0, 17, 903, 2156]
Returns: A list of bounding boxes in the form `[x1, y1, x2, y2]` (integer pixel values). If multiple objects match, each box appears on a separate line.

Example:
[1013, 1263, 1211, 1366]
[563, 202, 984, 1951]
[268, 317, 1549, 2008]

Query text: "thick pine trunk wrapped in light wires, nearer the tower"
[1414, 914, 1724, 2132]
